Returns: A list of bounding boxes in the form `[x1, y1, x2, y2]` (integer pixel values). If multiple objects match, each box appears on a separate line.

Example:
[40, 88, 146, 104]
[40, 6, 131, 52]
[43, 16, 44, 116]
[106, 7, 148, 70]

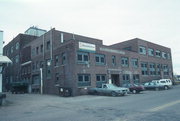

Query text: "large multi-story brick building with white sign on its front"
[3, 29, 173, 95]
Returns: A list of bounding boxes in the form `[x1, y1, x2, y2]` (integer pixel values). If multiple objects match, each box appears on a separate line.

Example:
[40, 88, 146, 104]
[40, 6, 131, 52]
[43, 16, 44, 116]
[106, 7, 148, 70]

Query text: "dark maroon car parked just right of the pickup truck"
[123, 84, 144, 94]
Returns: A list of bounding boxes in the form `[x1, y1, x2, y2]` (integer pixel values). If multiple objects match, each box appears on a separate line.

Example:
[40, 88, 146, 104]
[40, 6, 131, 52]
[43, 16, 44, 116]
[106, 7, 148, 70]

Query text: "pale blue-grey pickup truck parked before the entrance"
[88, 84, 129, 97]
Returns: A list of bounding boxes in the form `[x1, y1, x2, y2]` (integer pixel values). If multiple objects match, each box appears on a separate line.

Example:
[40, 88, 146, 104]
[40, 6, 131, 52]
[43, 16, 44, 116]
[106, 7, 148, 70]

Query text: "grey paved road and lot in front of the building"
[0, 85, 180, 121]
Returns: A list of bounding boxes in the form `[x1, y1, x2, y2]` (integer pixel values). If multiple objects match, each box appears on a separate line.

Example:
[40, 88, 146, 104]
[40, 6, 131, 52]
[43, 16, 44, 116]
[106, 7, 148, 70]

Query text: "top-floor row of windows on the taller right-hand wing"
[139, 46, 171, 59]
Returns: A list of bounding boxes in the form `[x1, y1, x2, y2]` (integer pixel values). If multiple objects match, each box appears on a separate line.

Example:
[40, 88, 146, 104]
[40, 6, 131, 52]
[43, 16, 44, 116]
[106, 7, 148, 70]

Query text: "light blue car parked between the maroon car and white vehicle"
[144, 82, 164, 90]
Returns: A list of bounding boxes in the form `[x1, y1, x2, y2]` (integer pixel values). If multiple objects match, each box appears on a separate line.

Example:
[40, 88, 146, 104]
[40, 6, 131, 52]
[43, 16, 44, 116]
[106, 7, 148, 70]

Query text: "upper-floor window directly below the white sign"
[77, 52, 89, 63]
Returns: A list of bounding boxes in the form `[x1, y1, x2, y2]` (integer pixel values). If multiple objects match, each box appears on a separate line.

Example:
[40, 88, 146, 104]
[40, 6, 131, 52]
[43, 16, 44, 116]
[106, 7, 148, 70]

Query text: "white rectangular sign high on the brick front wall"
[79, 42, 96, 51]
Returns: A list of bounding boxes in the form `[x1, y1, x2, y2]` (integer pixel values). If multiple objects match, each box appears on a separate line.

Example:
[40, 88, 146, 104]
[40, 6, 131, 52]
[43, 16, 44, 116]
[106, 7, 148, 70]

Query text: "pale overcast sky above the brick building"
[0, 0, 180, 74]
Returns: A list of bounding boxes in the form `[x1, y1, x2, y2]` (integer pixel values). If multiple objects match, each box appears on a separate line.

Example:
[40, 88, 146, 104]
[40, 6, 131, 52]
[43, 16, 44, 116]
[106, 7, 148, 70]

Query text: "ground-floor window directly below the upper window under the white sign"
[78, 74, 91, 87]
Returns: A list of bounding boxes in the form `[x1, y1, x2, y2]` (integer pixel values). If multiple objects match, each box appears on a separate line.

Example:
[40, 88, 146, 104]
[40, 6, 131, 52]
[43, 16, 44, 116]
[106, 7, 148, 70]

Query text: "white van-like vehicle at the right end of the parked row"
[152, 79, 172, 90]
